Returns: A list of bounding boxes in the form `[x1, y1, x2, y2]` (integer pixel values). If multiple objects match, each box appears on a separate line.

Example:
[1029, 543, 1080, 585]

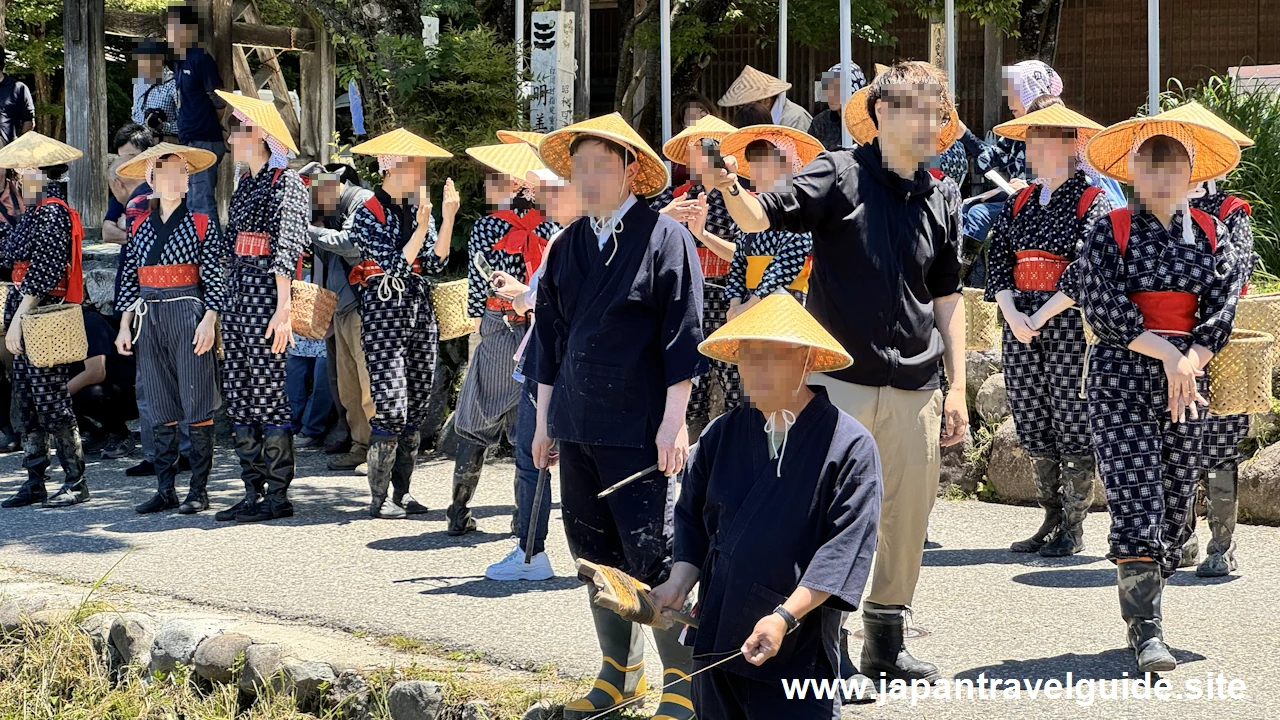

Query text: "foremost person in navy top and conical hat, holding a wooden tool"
[652, 291, 882, 720]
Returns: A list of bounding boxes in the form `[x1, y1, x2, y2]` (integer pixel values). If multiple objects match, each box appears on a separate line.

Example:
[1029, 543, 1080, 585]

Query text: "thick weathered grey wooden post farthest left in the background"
[63, 0, 109, 228]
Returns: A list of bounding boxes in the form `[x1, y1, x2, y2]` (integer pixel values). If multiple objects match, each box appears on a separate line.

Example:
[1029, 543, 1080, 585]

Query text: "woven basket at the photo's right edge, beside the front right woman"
[1208, 331, 1275, 415]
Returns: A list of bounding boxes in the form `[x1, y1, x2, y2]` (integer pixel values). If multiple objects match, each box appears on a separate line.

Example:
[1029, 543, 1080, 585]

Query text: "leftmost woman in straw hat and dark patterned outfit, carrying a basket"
[0, 132, 88, 507]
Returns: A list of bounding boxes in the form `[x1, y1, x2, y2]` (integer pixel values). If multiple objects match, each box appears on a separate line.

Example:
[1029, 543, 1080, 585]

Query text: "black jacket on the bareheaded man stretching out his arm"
[759, 141, 960, 389]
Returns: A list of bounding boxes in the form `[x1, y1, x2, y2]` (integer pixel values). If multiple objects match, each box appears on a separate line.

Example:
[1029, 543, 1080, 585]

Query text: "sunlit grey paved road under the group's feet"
[0, 451, 1280, 720]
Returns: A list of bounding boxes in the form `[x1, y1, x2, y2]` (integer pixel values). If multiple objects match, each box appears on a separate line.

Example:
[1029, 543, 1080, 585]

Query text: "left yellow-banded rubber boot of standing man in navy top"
[564, 588, 649, 720]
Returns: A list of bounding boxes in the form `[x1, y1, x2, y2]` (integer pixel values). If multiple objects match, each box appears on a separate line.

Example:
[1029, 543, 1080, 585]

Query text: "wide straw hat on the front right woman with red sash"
[1084, 115, 1240, 184]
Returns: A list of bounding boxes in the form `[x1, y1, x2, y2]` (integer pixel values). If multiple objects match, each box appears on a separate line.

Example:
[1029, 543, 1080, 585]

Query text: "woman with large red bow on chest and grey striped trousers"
[444, 142, 559, 536]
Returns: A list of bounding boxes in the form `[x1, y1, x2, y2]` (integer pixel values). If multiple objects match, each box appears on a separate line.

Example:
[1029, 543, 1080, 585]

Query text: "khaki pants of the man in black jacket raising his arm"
[809, 373, 942, 606]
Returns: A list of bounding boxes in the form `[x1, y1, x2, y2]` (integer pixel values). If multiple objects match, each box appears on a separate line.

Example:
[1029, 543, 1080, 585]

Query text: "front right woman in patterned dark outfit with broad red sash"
[1079, 118, 1244, 673]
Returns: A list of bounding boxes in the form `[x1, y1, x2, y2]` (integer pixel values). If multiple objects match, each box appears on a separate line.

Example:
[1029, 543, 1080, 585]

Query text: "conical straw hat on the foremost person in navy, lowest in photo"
[698, 292, 854, 373]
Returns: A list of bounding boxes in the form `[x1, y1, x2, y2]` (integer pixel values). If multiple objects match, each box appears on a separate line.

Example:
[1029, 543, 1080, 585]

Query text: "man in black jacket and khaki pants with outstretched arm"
[717, 63, 969, 682]
